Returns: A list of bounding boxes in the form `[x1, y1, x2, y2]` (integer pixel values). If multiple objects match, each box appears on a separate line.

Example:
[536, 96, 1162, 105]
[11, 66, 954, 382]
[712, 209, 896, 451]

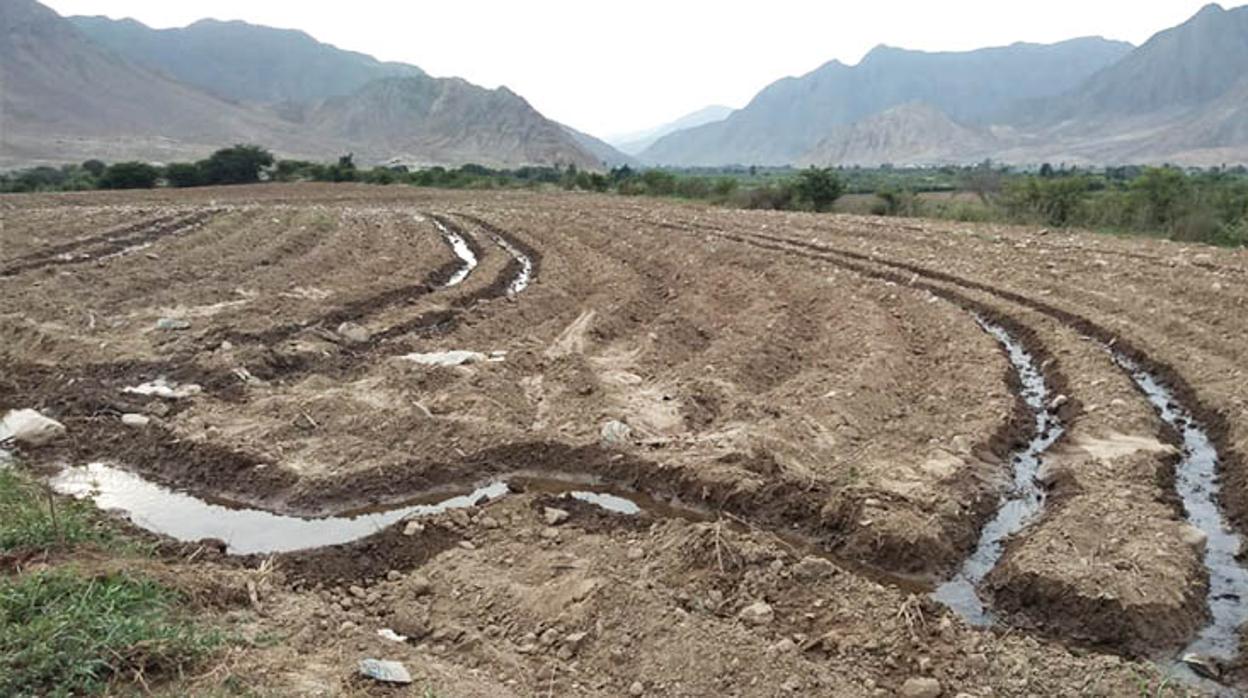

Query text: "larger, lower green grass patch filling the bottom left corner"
[0, 569, 222, 697]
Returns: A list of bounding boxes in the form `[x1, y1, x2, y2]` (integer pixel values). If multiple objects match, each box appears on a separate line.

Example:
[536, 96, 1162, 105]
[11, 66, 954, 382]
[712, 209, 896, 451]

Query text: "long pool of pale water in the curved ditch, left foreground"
[50, 463, 664, 554]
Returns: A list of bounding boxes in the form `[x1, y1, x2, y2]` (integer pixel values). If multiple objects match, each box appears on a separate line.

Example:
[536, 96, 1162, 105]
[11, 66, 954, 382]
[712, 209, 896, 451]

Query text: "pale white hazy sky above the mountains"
[44, 0, 1242, 136]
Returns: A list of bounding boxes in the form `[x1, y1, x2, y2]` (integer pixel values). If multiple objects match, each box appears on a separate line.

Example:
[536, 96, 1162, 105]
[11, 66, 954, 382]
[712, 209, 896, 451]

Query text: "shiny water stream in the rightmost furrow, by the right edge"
[1114, 355, 1248, 661]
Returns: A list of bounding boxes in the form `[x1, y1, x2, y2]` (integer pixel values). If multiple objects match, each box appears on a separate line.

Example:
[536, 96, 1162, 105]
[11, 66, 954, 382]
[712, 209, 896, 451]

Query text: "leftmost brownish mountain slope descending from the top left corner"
[0, 0, 312, 165]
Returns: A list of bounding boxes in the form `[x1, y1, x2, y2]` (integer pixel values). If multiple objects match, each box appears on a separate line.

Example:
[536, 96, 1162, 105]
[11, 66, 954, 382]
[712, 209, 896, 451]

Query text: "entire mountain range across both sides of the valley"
[0, 0, 1248, 170]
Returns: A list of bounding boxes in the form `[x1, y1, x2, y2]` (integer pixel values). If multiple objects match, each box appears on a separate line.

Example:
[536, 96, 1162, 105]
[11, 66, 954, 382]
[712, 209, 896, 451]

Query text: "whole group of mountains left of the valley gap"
[0, 0, 602, 170]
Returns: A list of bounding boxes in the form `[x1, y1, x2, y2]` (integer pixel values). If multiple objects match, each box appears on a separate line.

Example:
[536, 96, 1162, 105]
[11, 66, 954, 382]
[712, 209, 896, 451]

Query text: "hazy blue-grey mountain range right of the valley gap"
[638, 5, 1248, 166]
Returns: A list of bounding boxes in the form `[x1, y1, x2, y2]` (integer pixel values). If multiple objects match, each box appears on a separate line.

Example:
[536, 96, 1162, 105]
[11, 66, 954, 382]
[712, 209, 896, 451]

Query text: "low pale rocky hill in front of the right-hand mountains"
[799, 102, 997, 167]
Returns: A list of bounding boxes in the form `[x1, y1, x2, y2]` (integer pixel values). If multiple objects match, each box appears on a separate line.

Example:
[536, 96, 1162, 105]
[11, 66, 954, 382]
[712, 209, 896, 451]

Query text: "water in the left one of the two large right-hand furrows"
[932, 316, 1065, 627]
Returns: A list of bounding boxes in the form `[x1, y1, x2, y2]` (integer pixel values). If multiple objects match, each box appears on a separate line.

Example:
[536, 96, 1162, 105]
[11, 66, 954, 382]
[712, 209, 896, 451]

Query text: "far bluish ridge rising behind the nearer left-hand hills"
[69, 16, 424, 104]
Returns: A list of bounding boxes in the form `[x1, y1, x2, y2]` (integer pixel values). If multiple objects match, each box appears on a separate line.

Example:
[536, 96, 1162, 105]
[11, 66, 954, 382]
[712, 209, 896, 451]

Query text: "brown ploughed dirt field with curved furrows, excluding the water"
[0, 185, 1248, 697]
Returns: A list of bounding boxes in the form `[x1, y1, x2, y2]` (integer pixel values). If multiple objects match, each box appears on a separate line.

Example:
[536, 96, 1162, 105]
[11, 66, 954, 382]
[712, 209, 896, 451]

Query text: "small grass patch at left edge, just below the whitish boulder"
[0, 467, 122, 554]
